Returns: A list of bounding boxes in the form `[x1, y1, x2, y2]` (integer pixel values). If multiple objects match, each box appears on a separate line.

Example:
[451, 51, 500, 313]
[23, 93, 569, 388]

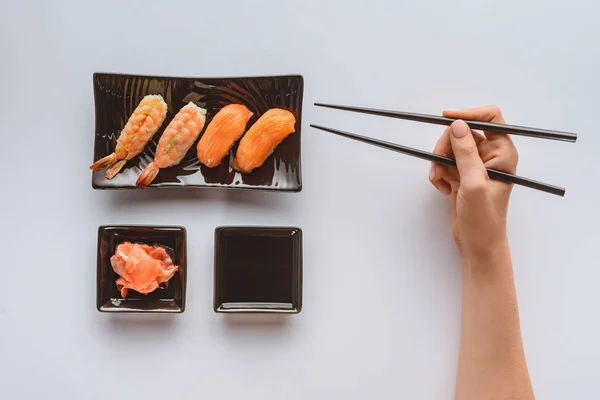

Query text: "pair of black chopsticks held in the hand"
[310, 103, 577, 197]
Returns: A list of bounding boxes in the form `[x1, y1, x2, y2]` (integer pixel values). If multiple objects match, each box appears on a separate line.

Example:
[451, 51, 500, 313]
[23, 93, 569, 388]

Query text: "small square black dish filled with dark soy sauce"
[214, 226, 302, 314]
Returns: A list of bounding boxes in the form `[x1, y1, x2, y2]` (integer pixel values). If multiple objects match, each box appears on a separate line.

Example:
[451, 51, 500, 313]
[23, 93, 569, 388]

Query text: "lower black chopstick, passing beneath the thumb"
[310, 124, 565, 197]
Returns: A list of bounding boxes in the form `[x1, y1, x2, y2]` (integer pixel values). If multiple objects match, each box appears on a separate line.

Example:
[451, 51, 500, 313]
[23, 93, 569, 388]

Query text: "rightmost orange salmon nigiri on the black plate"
[232, 108, 296, 174]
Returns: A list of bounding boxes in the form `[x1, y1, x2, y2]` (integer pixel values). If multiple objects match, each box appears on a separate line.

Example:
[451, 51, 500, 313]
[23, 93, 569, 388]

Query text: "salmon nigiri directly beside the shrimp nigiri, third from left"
[197, 104, 252, 168]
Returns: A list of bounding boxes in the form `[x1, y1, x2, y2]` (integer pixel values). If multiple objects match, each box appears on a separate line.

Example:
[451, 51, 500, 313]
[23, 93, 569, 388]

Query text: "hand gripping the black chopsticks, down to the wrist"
[429, 106, 518, 264]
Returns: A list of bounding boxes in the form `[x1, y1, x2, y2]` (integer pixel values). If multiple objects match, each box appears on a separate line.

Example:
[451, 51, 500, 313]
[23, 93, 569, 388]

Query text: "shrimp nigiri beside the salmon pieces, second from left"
[135, 101, 206, 189]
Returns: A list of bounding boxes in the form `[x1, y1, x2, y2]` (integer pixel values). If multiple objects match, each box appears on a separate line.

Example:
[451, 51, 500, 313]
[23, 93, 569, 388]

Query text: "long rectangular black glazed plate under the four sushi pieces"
[90, 73, 304, 192]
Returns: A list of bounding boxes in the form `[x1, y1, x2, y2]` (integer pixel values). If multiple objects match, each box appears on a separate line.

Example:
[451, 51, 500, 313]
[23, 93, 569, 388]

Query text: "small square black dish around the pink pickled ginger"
[96, 225, 187, 313]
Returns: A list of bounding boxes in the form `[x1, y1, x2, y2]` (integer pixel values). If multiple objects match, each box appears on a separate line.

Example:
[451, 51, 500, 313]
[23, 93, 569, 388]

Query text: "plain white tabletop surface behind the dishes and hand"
[0, 0, 600, 400]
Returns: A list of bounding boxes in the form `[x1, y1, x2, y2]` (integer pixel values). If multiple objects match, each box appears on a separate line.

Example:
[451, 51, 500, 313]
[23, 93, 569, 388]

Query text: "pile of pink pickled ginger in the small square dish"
[110, 242, 179, 299]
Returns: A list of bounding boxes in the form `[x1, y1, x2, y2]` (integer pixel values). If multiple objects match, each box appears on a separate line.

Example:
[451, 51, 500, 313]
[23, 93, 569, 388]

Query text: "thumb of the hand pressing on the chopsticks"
[450, 120, 488, 188]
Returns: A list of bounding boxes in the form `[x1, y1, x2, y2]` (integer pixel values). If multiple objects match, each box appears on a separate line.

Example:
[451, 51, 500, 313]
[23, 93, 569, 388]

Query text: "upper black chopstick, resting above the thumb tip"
[315, 103, 577, 143]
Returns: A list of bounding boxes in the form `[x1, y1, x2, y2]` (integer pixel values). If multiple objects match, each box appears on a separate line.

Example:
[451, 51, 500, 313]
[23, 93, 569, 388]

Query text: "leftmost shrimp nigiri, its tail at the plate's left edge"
[90, 95, 167, 179]
